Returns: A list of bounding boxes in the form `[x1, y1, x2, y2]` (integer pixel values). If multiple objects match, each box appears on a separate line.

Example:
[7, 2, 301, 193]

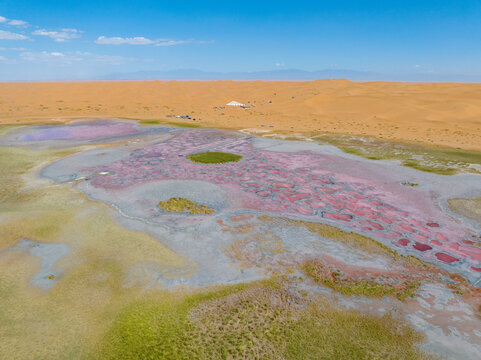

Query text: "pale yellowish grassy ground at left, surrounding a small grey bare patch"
[0, 139, 188, 359]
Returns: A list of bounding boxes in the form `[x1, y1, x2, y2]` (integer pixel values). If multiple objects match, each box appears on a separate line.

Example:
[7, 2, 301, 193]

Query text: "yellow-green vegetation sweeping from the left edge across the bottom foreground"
[0, 125, 430, 359]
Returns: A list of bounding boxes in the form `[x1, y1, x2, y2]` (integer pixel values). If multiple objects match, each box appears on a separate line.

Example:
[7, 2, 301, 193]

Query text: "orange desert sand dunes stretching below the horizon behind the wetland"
[0, 80, 481, 150]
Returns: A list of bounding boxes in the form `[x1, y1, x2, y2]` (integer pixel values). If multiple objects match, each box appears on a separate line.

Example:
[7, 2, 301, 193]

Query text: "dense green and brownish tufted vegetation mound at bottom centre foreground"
[93, 282, 424, 359]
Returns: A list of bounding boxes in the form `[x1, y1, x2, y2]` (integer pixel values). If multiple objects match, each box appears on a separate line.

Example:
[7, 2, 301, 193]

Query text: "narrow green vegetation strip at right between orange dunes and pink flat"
[314, 135, 481, 175]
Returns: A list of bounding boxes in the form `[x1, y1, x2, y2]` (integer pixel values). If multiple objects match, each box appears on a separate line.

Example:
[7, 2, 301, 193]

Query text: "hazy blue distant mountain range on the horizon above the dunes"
[99, 69, 481, 82]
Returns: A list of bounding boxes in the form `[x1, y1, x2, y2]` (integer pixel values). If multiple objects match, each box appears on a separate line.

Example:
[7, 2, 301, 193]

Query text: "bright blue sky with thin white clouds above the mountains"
[0, 0, 481, 80]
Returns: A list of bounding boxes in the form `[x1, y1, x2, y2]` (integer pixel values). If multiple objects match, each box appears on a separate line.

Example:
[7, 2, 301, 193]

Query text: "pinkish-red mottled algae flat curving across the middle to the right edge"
[36, 129, 481, 283]
